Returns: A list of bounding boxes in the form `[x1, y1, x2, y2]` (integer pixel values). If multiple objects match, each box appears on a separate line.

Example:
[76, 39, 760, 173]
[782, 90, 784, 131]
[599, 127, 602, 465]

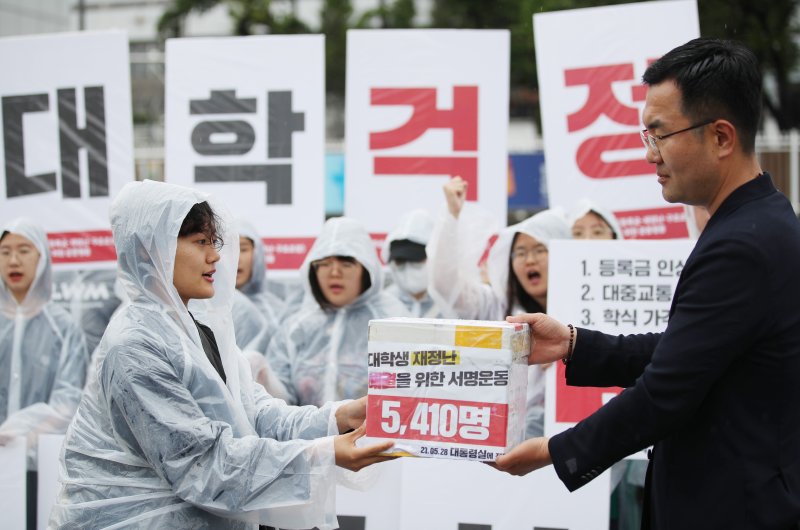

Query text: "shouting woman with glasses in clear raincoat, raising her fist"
[428, 177, 570, 438]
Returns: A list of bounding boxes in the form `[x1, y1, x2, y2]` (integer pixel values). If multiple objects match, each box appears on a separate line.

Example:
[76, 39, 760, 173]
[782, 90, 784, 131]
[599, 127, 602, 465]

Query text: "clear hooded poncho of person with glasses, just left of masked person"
[267, 217, 408, 405]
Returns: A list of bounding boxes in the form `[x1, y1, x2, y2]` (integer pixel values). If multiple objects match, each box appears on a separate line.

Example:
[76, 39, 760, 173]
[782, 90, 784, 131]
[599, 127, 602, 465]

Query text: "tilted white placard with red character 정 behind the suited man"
[533, 0, 700, 239]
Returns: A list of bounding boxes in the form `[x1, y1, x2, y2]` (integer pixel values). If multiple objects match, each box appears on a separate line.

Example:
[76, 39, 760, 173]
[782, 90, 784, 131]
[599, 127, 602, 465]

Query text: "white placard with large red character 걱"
[344, 30, 510, 234]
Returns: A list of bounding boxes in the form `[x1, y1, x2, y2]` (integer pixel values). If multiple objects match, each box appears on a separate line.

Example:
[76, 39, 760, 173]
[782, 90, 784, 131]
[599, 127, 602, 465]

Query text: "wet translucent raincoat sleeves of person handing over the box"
[101, 334, 335, 524]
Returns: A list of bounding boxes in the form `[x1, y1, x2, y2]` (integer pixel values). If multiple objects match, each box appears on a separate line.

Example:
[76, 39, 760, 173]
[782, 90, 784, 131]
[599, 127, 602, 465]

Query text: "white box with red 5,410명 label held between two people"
[358, 318, 530, 461]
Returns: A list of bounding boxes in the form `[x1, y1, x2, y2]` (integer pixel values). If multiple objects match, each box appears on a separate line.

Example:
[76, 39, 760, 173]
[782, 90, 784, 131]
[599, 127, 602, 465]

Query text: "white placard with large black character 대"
[0, 31, 134, 268]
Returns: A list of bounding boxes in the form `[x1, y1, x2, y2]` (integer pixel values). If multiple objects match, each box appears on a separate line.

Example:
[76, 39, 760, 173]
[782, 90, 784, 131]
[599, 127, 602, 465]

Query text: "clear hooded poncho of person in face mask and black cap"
[383, 209, 446, 318]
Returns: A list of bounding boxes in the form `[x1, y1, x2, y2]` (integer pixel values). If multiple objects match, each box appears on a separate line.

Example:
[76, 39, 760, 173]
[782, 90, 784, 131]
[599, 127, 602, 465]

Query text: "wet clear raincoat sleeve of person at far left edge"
[0, 307, 89, 446]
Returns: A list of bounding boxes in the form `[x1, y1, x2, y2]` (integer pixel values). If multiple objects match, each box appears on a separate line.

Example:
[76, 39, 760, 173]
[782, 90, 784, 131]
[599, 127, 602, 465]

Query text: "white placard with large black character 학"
[165, 35, 325, 271]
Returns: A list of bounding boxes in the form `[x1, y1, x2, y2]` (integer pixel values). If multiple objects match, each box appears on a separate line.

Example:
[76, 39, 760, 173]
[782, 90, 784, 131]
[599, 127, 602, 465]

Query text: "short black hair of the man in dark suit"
[642, 38, 762, 153]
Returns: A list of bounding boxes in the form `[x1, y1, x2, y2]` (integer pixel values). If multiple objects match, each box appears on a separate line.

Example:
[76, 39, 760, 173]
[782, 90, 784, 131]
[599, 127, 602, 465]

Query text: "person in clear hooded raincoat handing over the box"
[50, 181, 386, 530]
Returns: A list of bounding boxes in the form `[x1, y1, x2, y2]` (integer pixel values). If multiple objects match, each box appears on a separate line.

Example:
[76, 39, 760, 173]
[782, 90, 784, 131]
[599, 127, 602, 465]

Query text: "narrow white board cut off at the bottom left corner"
[0, 437, 27, 528]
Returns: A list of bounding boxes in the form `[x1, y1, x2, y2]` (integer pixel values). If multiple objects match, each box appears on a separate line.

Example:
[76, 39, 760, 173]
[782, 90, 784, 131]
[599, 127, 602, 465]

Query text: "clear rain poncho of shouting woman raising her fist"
[428, 208, 572, 438]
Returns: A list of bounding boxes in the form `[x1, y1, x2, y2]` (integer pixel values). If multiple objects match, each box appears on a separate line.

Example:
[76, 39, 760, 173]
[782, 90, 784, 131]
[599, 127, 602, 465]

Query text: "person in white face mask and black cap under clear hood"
[383, 210, 444, 318]
